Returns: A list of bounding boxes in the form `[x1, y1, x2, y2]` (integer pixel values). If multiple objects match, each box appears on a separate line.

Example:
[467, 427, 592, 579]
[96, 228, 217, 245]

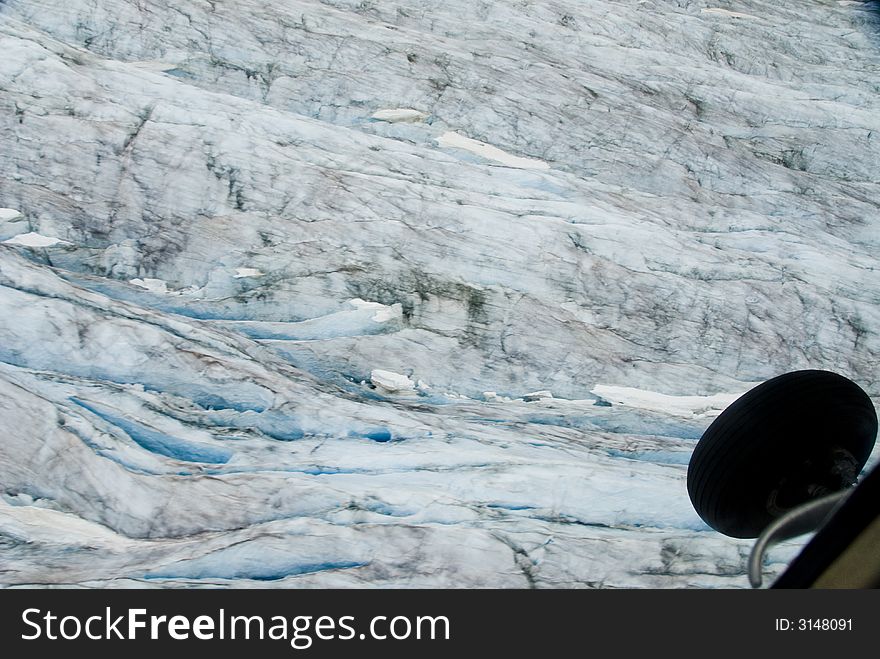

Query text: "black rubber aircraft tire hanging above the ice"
[687, 371, 877, 538]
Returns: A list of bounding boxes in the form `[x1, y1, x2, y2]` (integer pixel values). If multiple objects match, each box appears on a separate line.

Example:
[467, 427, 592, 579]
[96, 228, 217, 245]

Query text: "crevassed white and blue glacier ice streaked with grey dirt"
[0, 0, 880, 588]
